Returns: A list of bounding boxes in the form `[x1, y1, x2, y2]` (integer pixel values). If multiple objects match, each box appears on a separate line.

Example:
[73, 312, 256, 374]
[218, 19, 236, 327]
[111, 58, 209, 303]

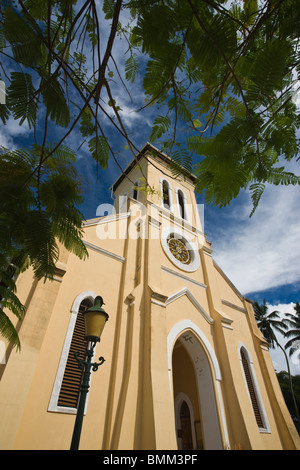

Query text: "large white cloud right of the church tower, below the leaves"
[213, 173, 300, 294]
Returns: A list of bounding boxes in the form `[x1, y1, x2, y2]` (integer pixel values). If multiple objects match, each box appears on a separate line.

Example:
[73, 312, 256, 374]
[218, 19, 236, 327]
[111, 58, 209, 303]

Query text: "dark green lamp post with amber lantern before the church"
[70, 296, 108, 450]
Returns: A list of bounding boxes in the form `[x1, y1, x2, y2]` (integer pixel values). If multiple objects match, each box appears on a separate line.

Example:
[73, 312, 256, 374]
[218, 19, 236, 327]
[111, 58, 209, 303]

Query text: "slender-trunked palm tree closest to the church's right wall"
[253, 299, 300, 422]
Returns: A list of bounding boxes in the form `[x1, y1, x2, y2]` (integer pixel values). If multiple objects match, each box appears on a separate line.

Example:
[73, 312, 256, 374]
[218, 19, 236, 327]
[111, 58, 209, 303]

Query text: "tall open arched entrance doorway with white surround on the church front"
[170, 324, 223, 450]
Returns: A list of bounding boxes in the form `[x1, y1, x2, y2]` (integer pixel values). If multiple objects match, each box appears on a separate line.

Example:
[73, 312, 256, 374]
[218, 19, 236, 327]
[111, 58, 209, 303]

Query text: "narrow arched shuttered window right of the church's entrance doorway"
[240, 347, 268, 429]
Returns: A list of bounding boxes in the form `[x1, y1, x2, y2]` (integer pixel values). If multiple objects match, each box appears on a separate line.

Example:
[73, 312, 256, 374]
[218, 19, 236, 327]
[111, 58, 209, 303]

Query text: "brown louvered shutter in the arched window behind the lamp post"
[57, 300, 91, 408]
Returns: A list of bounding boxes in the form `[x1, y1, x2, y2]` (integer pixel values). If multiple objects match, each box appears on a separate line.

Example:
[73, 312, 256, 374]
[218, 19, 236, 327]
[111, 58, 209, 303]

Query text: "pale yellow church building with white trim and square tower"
[0, 144, 300, 450]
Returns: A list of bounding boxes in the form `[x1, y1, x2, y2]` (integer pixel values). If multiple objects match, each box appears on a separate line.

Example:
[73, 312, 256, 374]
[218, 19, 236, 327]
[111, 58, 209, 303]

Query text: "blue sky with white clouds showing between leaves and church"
[0, 0, 300, 374]
